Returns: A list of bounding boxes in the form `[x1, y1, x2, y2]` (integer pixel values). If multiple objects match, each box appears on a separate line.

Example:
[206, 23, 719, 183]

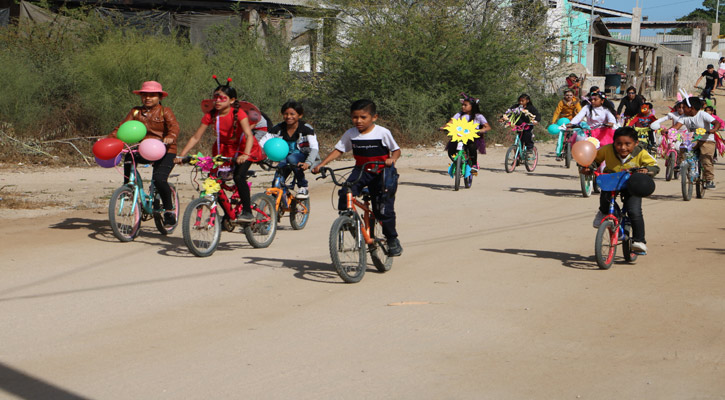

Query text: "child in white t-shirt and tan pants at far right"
[673, 97, 721, 189]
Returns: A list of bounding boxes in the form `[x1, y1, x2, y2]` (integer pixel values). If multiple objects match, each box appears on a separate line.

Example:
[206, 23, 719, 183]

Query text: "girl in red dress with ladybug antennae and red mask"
[175, 76, 264, 222]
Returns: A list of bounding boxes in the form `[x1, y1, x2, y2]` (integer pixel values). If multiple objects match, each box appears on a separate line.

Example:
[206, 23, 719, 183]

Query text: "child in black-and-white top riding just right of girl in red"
[259, 100, 320, 199]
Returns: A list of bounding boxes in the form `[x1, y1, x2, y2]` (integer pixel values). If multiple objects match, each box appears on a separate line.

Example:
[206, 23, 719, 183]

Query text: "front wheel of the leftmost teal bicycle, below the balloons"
[108, 186, 141, 242]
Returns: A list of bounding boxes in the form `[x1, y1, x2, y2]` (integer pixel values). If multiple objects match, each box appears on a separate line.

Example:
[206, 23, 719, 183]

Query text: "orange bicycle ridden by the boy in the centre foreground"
[317, 161, 393, 283]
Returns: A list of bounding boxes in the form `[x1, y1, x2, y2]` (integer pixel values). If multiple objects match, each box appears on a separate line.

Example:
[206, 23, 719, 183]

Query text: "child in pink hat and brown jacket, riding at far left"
[108, 81, 179, 226]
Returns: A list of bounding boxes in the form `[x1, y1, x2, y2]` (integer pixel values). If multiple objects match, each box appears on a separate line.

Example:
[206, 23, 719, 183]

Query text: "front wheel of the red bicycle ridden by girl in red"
[181, 197, 222, 257]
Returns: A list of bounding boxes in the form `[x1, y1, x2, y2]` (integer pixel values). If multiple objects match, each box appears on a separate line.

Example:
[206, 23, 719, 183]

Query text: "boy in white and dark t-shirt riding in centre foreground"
[312, 99, 403, 257]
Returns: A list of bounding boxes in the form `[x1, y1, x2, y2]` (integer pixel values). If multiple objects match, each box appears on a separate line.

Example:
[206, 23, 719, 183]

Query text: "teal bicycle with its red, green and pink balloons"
[93, 121, 179, 242]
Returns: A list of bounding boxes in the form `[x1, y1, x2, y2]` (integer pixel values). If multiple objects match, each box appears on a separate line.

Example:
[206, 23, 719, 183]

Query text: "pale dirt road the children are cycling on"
[0, 97, 725, 399]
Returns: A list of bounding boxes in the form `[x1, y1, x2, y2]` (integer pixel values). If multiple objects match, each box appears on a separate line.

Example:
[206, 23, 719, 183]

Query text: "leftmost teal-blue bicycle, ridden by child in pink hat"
[108, 145, 179, 242]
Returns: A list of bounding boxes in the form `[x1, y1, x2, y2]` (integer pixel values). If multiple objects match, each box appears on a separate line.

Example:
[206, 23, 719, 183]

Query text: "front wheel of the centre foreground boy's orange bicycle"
[330, 215, 366, 283]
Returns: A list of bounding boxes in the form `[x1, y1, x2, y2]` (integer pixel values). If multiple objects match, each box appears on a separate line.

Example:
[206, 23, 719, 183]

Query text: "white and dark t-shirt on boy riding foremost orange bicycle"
[335, 125, 400, 165]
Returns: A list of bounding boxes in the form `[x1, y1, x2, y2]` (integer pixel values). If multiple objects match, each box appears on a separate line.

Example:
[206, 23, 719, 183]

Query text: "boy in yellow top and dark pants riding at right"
[584, 126, 660, 253]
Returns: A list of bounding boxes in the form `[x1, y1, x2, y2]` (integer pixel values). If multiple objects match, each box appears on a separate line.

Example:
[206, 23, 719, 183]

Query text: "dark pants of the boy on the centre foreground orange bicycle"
[337, 167, 398, 240]
